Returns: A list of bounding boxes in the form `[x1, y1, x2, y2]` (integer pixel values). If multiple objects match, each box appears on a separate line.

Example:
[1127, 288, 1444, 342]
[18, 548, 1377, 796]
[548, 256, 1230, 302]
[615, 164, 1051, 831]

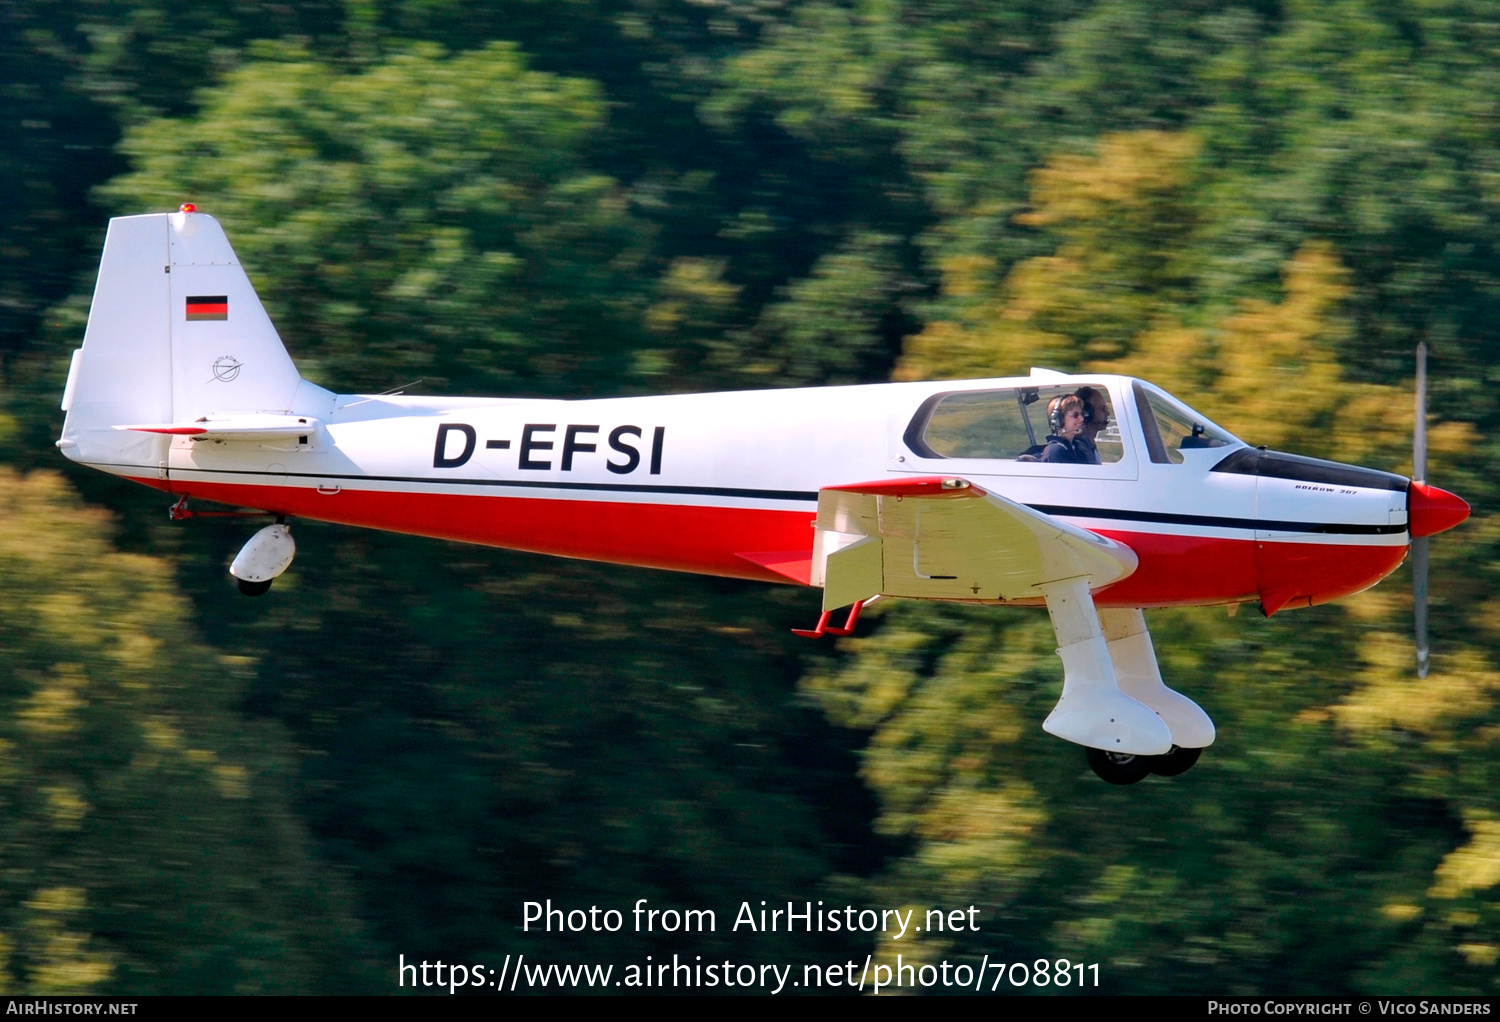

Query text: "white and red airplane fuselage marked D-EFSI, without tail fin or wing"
[102, 374, 1409, 611]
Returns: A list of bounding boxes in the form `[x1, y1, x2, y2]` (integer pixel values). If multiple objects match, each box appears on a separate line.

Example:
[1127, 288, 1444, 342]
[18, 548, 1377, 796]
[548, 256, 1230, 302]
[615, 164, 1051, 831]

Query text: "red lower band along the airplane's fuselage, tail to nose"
[135, 479, 1407, 608]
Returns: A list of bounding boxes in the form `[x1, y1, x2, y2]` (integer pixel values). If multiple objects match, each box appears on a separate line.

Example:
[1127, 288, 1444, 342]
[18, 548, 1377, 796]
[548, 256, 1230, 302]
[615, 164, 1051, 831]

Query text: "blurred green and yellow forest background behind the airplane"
[0, 0, 1500, 995]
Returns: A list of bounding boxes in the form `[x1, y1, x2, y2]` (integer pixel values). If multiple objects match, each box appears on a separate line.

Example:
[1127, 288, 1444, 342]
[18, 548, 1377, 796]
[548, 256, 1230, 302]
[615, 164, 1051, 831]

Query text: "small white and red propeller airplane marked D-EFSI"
[57, 204, 1469, 783]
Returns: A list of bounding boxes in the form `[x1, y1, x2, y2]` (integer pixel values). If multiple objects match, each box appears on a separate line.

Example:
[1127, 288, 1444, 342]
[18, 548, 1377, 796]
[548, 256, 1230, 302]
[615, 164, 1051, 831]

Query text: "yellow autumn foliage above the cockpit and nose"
[896, 132, 1475, 467]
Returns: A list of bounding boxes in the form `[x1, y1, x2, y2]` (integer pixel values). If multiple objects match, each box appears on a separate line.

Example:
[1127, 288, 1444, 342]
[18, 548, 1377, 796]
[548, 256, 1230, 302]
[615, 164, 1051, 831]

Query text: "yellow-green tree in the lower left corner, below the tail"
[0, 471, 366, 993]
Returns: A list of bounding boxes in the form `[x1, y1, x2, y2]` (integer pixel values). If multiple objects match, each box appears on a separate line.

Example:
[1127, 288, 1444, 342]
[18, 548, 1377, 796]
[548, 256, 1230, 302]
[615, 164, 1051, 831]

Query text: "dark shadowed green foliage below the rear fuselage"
[210, 534, 869, 962]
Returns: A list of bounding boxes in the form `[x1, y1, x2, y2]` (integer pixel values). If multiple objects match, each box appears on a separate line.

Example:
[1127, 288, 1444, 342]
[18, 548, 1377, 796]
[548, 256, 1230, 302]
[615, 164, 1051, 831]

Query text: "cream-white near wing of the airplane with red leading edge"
[812, 476, 1137, 609]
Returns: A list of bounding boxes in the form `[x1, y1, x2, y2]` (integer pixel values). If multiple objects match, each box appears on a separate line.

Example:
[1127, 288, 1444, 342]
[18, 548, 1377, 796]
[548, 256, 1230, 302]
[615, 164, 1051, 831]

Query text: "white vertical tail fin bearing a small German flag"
[59, 212, 300, 470]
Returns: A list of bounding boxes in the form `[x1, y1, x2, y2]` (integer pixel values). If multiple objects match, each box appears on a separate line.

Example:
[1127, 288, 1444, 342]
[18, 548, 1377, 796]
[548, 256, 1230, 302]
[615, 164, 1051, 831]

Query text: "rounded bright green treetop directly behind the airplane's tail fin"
[107, 44, 648, 393]
